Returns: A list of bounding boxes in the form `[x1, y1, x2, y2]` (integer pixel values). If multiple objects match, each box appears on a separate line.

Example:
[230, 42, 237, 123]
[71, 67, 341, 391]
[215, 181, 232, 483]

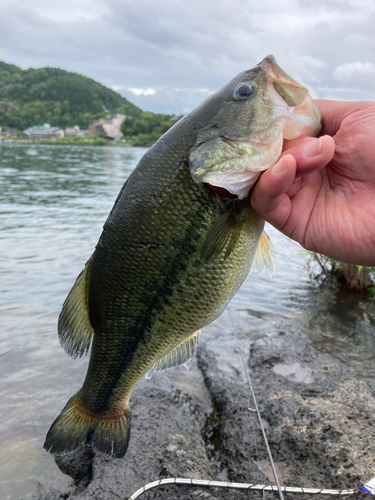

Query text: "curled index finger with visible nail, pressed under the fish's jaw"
[282, 135, 335, 177]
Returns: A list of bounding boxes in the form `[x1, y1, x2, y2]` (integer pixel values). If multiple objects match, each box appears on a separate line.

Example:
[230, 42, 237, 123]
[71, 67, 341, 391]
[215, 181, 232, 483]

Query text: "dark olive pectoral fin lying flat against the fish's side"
[200, 206, 242, 263]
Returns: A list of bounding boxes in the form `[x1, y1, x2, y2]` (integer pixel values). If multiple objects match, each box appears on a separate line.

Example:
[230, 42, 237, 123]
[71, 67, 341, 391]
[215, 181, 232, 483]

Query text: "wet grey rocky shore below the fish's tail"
[36, 320, 375, 500]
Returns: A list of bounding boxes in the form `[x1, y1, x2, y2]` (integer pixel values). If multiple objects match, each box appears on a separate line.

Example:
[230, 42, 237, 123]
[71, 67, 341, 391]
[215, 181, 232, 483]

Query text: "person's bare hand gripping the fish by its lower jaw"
[250, 99, 375, 266]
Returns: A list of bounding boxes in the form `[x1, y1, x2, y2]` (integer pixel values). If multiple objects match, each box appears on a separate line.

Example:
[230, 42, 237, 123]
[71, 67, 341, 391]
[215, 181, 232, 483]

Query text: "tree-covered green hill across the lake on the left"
[0, 61, 142, 130]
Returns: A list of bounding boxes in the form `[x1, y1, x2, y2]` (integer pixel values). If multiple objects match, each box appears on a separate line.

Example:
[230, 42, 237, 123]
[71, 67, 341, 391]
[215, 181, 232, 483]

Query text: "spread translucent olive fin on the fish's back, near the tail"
[58, 257, 94, 358]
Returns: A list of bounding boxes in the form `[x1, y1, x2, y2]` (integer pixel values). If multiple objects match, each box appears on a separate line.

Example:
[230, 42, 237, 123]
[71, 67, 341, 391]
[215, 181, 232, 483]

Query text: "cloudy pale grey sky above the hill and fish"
[0, 0, 375, 114]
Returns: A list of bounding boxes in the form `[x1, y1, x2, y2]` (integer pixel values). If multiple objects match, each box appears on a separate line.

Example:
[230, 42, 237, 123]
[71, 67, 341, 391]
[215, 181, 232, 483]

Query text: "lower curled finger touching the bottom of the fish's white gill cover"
[250, 155, 297, 228]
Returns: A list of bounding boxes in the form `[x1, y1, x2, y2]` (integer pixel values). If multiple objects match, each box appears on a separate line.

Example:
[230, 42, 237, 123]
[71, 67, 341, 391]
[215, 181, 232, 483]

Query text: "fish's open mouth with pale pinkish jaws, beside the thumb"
[259, 55, 323, 140]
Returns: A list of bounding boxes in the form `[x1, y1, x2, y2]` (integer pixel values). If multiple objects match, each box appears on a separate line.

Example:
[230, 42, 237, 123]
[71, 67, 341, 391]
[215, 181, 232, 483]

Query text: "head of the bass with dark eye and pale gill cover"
[189, 55, 322, 199]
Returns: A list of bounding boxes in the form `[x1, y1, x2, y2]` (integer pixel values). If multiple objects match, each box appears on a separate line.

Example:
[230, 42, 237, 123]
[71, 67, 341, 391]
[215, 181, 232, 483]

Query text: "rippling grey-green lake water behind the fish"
[0, 145, 375, 500]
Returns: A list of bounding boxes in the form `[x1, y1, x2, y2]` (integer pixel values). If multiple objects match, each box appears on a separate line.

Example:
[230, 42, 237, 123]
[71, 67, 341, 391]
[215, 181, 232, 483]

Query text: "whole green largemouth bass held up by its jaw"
[44, 55, 322, 458]
